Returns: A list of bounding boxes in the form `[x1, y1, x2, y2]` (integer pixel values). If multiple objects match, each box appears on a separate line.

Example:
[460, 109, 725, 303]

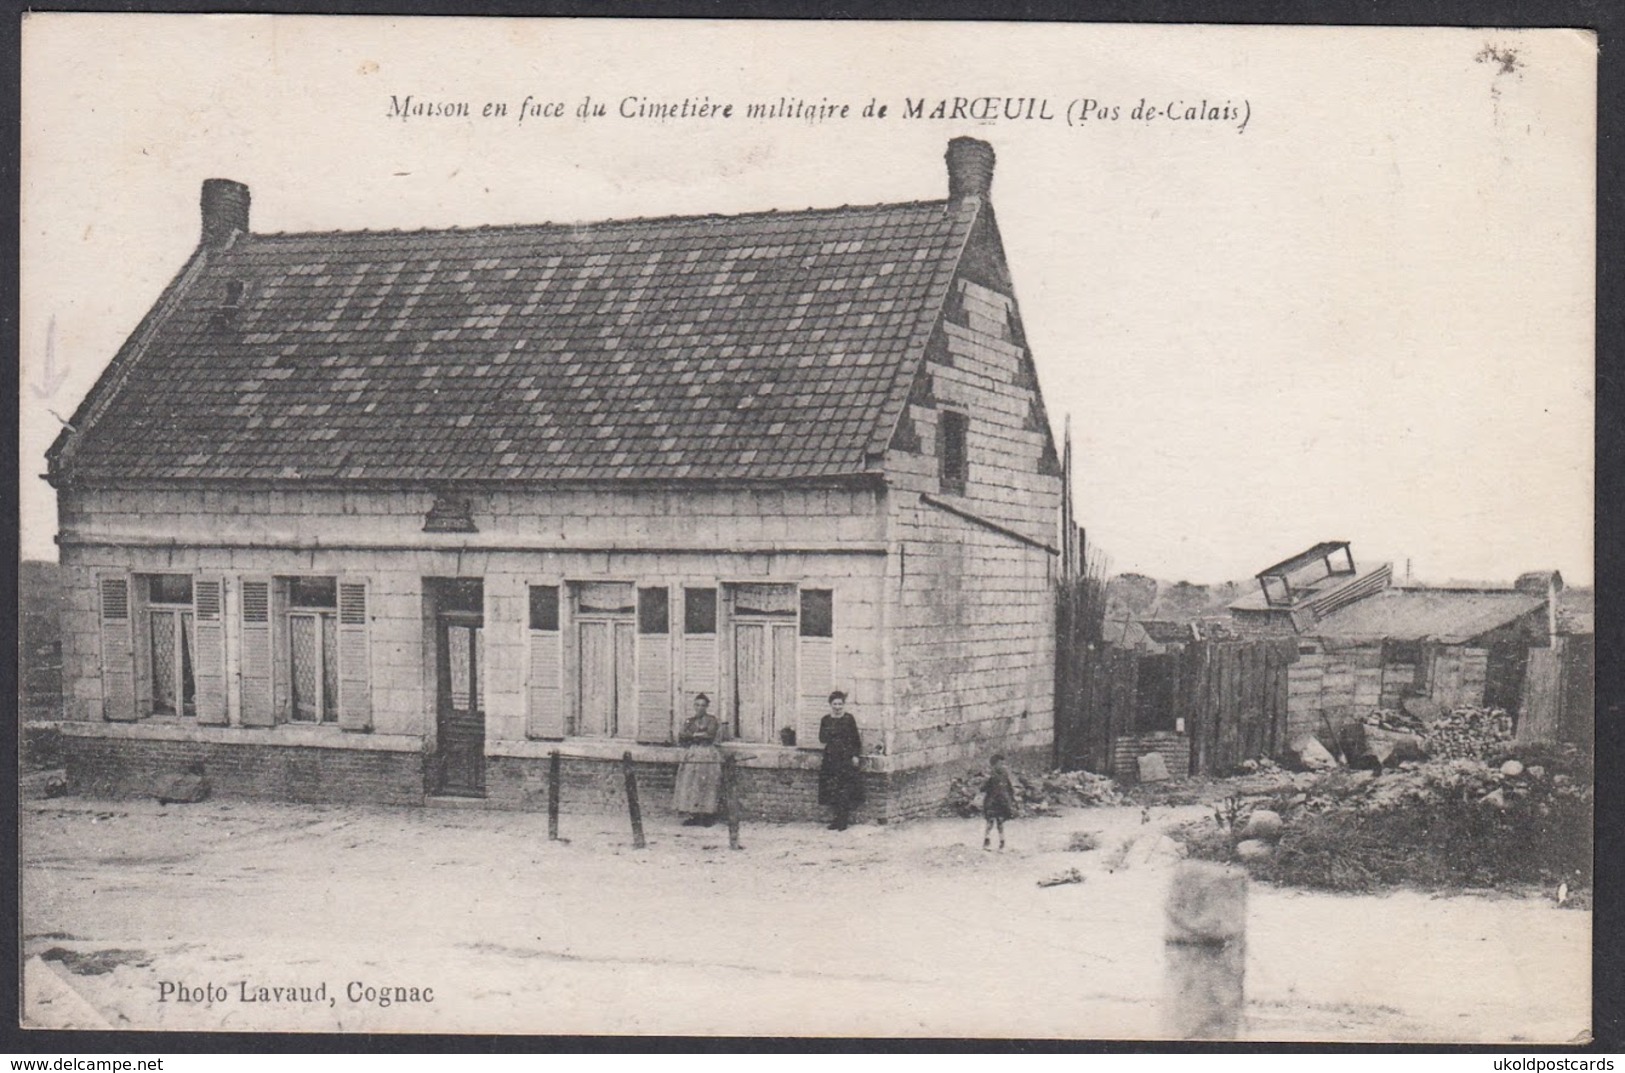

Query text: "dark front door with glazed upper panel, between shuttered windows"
[431, 579, 486, 797]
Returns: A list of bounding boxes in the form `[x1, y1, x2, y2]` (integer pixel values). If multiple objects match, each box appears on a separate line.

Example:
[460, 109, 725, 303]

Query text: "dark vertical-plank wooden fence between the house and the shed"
[1056, 637, 1298, 775]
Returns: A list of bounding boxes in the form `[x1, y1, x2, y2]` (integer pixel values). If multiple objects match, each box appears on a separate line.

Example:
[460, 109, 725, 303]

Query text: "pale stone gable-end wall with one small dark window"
[887, 278, 1061, 766]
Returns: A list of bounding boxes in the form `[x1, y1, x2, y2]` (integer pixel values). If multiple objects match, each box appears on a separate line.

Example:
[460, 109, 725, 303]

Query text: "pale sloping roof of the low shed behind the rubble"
[1315, 589, 1545, 644]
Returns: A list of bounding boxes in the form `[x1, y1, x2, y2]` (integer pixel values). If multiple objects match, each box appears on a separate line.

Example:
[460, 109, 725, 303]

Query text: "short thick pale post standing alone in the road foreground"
[1162, 860, 1246, 1039]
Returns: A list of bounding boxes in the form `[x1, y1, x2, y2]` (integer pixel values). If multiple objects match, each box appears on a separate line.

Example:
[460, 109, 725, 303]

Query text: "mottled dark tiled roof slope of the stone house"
[67, 198, 982, 481]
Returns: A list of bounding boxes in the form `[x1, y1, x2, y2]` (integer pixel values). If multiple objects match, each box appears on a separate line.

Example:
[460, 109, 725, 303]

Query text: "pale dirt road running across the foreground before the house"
[23, 798, 1591, 1042]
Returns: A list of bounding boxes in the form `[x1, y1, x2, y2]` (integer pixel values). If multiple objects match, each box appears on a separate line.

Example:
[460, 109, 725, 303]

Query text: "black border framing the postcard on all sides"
[0, 0, 1625, 1055]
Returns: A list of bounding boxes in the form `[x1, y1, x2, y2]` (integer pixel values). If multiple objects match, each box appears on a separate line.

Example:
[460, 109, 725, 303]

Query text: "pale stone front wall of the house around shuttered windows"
[60, 489, 889, 753]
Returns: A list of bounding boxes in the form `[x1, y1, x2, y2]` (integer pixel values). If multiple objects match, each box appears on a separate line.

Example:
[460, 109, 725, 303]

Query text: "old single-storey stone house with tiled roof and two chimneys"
[49, 138, 1061, 818]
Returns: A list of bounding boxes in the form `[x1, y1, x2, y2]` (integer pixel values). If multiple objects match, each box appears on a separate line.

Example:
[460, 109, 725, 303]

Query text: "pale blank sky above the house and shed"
[20, 15, 1596, 584]
